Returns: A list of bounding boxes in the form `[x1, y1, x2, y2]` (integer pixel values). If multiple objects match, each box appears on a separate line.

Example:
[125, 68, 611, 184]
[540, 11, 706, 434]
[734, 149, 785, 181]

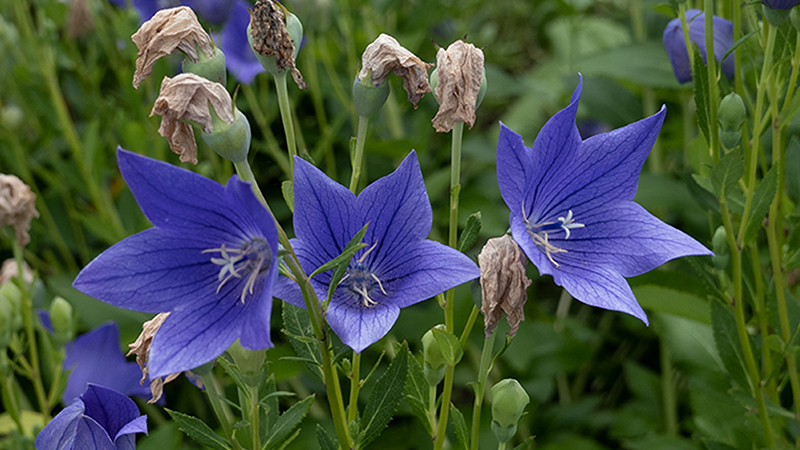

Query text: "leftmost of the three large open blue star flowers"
[73, 149, 278, 378]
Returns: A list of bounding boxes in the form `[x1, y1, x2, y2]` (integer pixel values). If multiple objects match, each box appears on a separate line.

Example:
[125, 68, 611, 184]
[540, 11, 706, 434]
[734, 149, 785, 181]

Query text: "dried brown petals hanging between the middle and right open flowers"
[478, 235, 531, 337]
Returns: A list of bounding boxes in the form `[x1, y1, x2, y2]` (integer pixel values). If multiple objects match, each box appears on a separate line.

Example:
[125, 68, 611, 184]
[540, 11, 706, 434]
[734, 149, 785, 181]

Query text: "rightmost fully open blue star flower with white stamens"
[497, 77, 712, 323]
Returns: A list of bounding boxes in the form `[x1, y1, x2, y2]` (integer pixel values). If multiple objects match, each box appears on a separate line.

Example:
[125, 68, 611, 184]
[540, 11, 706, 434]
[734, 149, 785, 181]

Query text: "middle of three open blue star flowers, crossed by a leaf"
[275, 152, 480, 352]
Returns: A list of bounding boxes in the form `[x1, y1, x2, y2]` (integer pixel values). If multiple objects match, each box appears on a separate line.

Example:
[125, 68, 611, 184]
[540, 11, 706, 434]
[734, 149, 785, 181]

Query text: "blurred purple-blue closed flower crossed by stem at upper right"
[663, 9, 736, 83]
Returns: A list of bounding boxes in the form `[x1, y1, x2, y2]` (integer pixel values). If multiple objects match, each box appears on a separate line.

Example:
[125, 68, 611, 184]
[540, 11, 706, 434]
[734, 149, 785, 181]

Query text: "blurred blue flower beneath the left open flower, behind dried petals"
[62, 322, 150, 405]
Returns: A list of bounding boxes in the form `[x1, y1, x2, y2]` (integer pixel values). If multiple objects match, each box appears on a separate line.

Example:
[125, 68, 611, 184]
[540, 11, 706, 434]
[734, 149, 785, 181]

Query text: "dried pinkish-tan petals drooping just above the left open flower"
[150, 73, 234, 164]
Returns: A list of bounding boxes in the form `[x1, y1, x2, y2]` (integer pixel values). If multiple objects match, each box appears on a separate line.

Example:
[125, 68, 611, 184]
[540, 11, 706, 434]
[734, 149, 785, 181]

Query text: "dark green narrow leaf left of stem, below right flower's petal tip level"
[711, 300, 750, 392]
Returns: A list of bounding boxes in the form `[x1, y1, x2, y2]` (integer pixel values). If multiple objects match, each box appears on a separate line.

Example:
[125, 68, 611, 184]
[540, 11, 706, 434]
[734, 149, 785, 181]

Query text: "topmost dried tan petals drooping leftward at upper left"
[131, 6, 215, 89]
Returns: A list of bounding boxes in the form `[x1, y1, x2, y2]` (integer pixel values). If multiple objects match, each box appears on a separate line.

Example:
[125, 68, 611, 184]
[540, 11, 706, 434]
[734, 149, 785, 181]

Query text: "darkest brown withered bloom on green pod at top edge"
[248, 0, 306, 89]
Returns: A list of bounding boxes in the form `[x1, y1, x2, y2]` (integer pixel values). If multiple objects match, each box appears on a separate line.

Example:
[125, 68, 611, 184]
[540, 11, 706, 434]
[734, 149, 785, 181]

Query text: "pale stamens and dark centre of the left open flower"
[203, 238, 272, 303]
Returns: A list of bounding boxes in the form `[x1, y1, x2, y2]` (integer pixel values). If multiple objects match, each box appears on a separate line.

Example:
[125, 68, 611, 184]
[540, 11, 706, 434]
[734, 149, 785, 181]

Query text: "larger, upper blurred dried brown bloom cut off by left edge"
[0, 174, 39, 247]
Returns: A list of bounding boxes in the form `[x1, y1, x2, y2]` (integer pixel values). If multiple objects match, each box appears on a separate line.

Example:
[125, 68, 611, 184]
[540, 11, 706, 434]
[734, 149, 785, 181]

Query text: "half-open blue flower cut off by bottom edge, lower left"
[35, 384, 147, 450]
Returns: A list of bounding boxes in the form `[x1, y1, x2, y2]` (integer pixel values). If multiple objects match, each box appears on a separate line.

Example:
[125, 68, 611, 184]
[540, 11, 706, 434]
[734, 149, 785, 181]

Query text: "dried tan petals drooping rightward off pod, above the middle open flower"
[358, 34, 433, 108]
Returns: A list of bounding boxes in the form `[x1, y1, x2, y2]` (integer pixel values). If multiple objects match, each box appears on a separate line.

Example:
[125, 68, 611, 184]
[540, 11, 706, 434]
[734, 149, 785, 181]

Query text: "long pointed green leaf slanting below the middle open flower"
[359, 342, 409, 448]
